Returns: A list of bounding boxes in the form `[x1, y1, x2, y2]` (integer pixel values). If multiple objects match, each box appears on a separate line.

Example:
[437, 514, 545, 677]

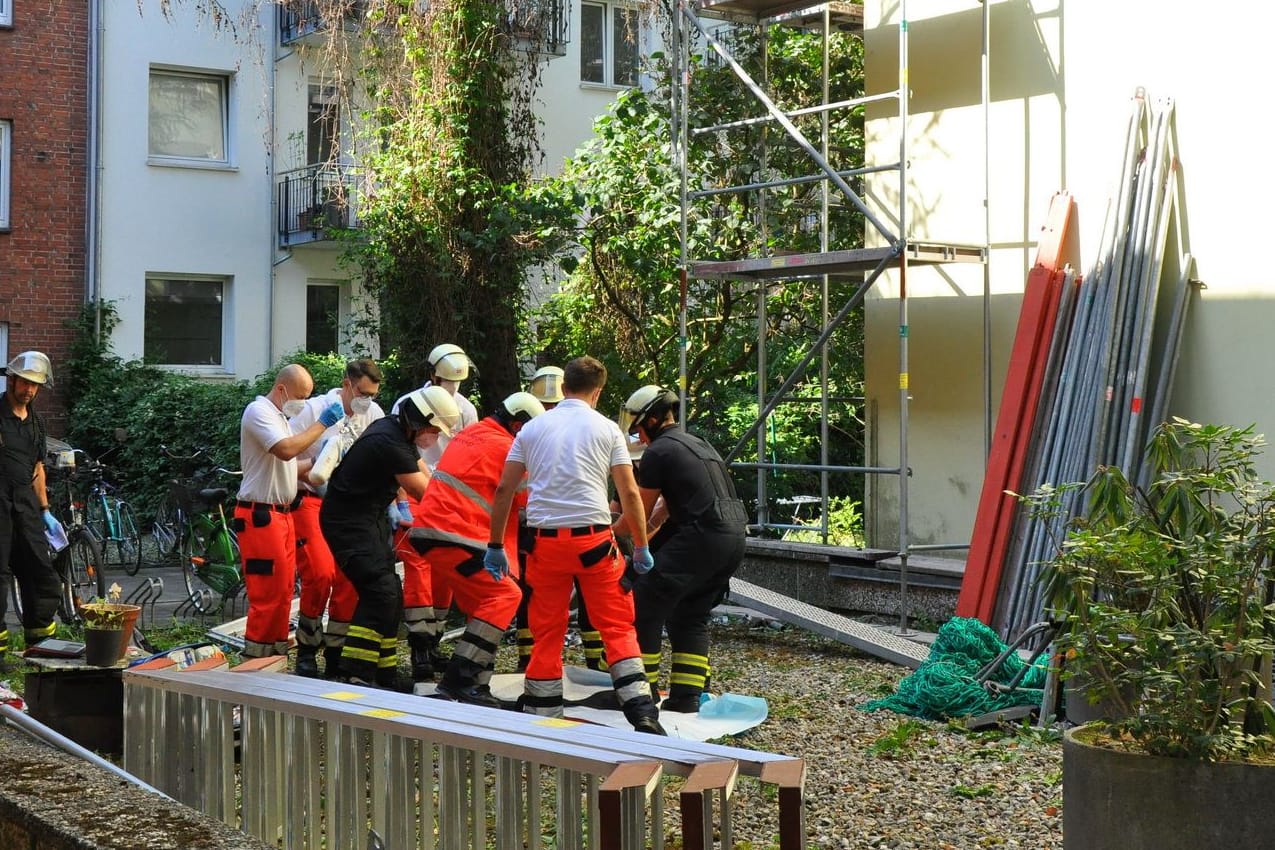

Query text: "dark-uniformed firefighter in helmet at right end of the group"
[616, 385, 748, 712]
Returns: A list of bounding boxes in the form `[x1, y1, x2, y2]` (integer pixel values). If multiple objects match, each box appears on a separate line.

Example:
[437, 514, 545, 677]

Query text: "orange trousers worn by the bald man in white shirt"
[235, 506, 297, 658]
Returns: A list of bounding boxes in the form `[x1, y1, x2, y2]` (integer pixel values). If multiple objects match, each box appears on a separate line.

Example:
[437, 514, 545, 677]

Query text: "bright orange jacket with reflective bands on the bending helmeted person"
[412, 417, 527, 552]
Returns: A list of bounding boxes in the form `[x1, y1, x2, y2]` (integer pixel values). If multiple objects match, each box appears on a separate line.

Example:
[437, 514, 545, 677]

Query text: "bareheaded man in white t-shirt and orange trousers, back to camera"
[483, 357, 664, 735]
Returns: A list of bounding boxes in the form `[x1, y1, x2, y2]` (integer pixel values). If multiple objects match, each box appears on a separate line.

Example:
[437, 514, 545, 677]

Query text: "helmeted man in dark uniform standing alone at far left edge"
[0, 352, 65, 663]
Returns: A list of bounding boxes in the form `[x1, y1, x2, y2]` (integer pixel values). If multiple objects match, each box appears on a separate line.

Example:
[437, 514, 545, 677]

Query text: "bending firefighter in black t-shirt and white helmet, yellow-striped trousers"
[319, 386, 460, 687]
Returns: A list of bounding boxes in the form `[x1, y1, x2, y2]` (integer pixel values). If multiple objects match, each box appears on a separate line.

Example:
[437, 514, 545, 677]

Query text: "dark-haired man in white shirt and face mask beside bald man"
[291, 357, 385, 678]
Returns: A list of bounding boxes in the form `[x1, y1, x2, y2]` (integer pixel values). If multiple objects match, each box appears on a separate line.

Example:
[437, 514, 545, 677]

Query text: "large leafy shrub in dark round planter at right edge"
[1028, 419, 1275, 850]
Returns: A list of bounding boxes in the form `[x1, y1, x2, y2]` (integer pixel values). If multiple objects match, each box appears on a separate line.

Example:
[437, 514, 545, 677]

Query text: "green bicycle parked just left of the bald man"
[153, 446, 244, 614]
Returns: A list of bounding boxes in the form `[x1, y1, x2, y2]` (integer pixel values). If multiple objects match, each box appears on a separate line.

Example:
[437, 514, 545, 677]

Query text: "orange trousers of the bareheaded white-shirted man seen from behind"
[524, 529, 641, 679]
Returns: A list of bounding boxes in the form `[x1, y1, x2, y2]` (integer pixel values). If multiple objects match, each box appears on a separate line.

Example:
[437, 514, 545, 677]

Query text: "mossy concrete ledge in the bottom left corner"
[0, 724, 268, 850]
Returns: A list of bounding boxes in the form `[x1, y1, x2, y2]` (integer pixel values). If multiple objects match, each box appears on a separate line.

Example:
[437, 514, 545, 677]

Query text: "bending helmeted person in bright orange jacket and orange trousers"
[403, 393, 544, 709]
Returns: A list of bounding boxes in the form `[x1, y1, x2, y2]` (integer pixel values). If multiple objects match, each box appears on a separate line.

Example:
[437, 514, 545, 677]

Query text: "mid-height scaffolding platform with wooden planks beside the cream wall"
[690, 242, 987, 280]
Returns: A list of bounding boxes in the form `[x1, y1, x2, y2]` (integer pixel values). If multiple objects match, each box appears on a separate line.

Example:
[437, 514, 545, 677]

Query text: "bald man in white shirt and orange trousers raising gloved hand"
[235, 363, 344, 658]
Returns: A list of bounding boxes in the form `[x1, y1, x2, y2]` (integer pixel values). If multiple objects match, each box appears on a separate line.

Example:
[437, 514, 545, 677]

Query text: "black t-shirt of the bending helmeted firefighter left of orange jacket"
[323, 417, 419, 528]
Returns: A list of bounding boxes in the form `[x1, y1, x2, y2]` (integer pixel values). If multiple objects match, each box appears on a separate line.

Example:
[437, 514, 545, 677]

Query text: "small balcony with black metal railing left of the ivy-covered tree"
[278, 164, 361, 249]
